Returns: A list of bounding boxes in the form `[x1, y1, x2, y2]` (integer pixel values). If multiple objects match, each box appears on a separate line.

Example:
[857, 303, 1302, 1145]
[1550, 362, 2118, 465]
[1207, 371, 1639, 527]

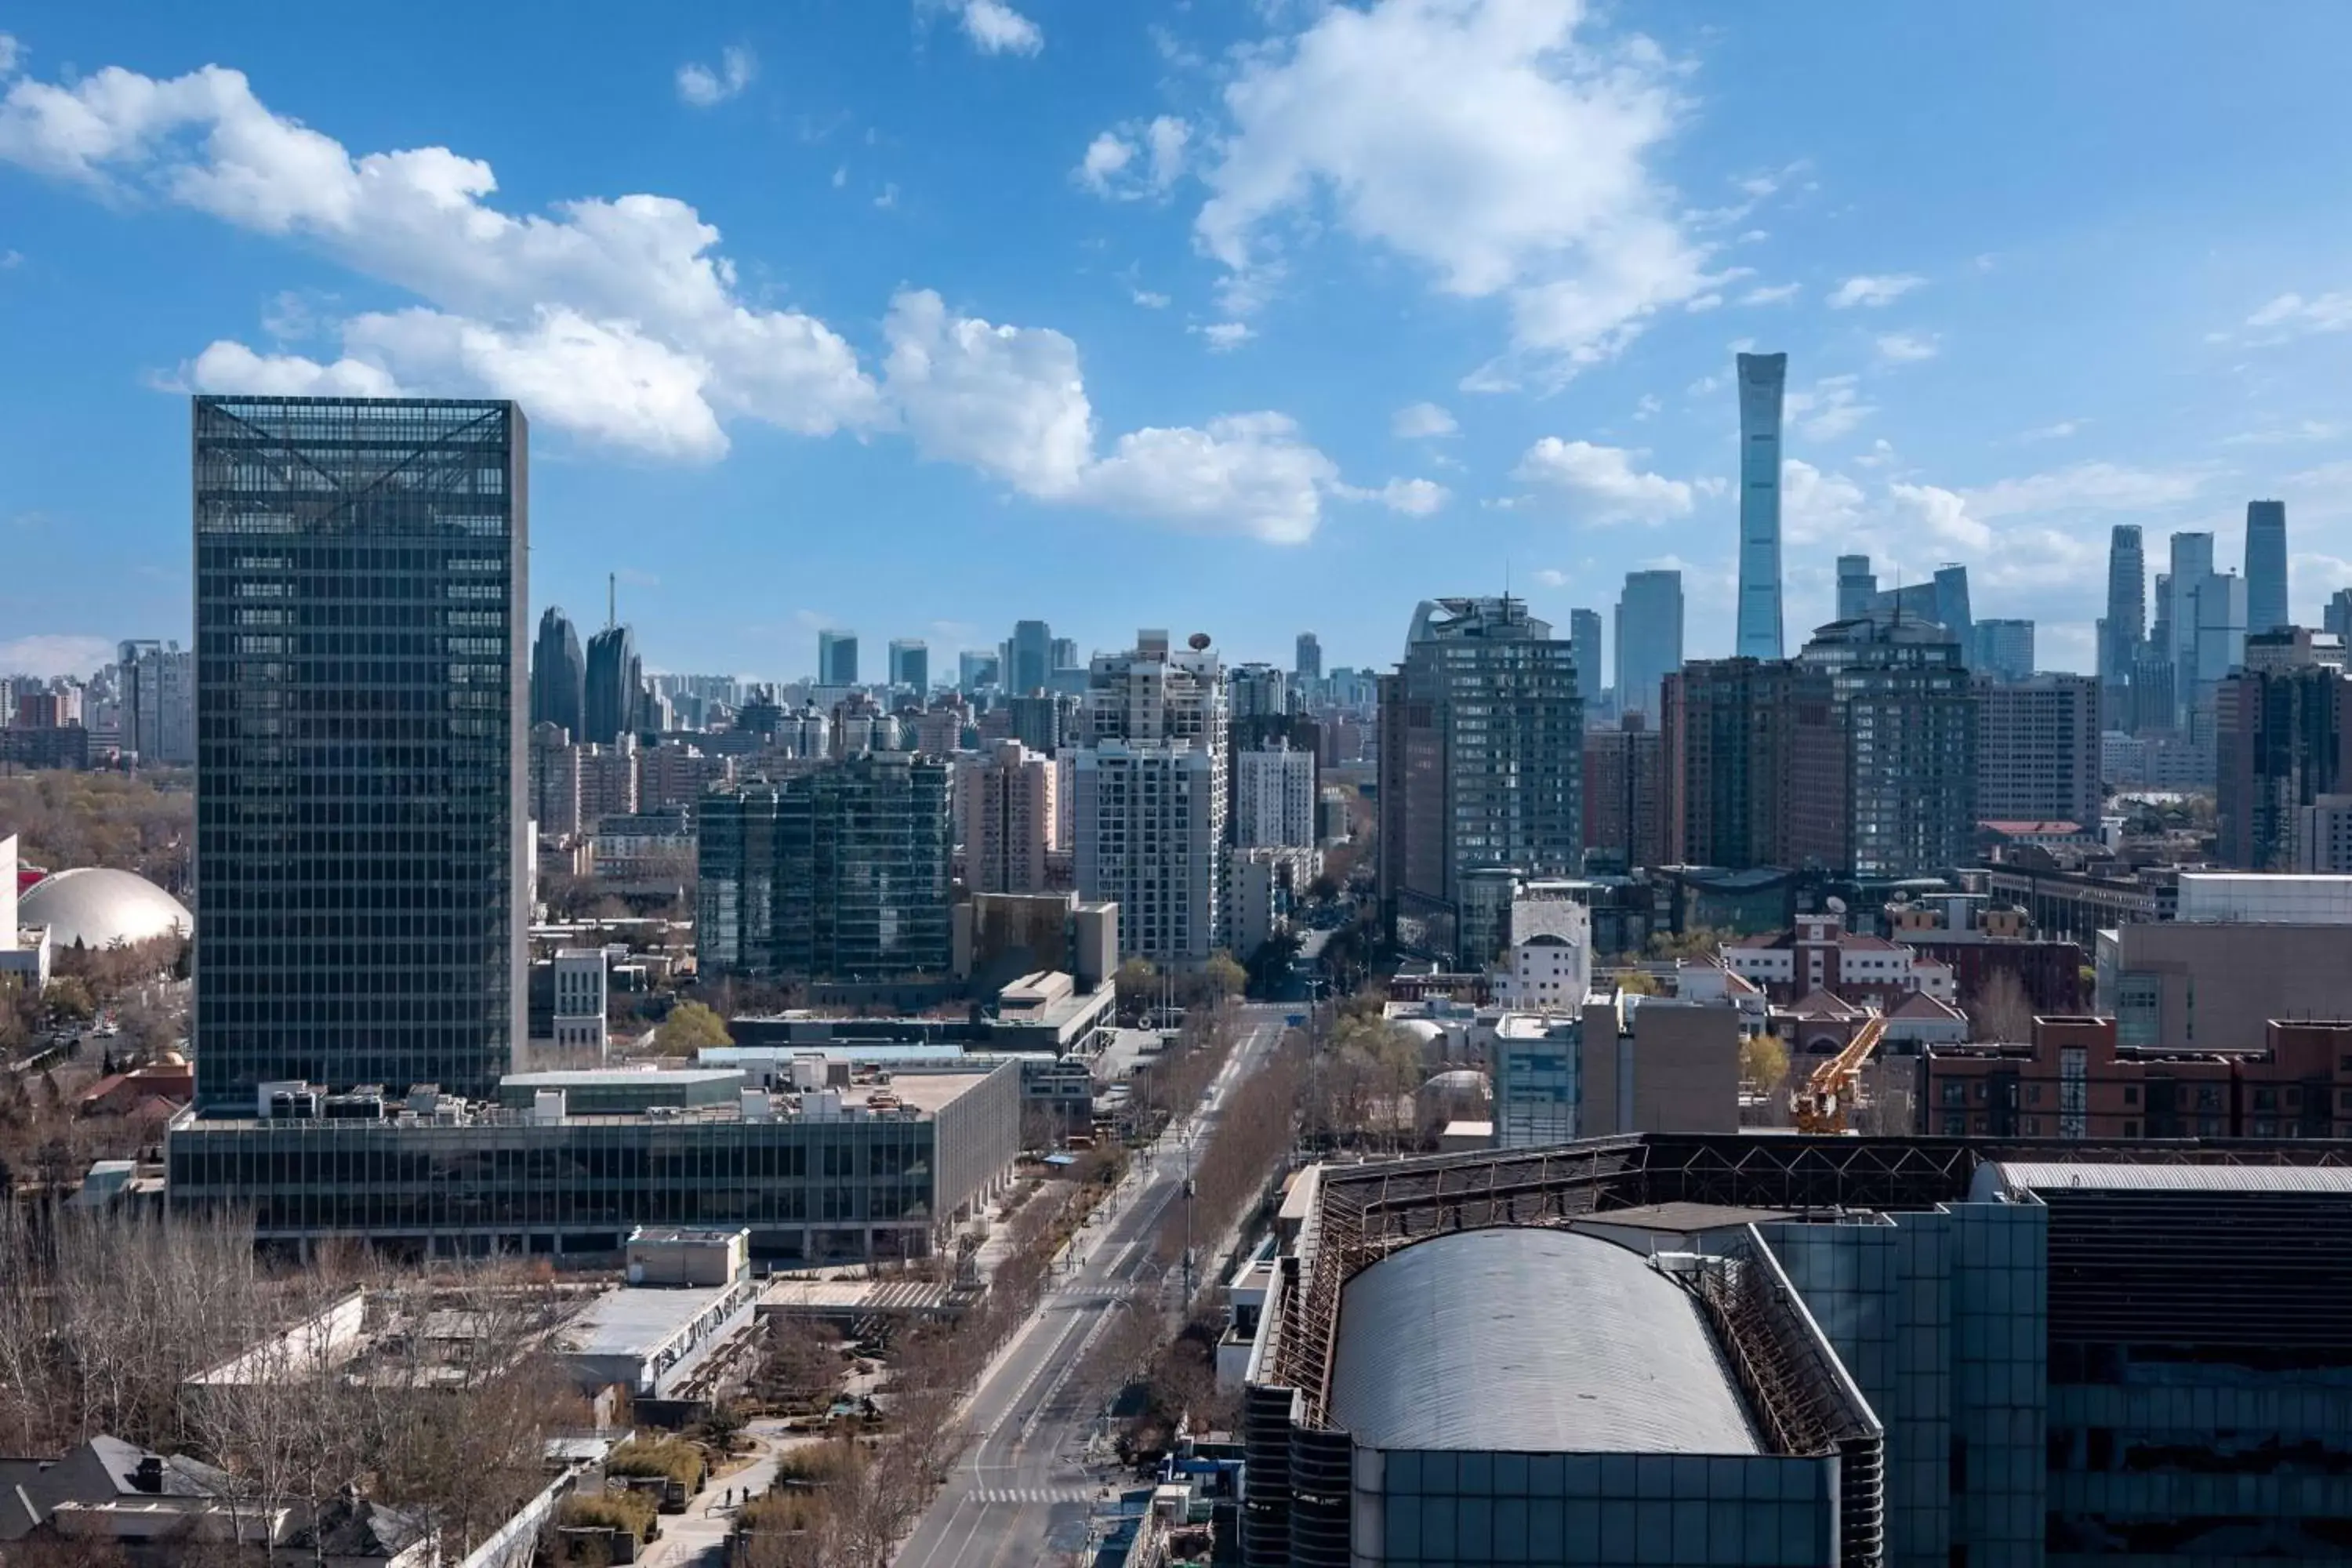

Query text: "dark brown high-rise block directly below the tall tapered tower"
[1661, 659, 1797, 869]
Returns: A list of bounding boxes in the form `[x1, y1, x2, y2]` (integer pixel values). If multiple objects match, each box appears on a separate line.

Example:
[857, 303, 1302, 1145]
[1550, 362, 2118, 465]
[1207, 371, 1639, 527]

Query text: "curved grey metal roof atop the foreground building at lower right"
[1331, 1229, 1759, 1453]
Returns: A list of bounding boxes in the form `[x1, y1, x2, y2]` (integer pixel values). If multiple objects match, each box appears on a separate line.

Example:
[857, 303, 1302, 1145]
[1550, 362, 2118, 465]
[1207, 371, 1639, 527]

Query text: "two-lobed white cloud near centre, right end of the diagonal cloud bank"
[884, 292, 1364, 543]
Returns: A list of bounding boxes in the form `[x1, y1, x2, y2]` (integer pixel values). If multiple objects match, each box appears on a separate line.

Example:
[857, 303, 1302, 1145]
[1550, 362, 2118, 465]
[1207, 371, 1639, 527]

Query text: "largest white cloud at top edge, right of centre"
[1195, 0, 1715, 388]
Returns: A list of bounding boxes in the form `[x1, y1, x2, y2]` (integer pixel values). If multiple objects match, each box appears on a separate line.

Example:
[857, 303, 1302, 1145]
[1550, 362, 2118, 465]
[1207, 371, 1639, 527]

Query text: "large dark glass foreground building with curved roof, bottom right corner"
[1242, 1133, 2352, 1568]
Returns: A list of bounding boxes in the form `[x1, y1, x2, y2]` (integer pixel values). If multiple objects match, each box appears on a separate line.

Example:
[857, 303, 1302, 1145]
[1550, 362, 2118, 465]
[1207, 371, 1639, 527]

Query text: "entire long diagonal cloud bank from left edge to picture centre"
[0, 53, 1392, 541]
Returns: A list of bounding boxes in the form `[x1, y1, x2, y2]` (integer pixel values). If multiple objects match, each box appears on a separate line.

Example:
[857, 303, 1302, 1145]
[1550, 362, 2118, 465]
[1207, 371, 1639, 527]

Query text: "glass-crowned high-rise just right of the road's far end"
[1378, 597, 1585, 964]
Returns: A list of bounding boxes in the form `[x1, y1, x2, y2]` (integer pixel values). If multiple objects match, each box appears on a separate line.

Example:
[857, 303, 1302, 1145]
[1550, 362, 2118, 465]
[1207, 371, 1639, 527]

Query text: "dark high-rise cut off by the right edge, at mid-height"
[2213, 628, 2352, 872]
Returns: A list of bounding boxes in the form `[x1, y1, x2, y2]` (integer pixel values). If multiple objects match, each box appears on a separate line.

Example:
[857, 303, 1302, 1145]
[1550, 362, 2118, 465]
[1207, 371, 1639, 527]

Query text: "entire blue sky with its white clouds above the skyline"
[0, 0, 2352, 675]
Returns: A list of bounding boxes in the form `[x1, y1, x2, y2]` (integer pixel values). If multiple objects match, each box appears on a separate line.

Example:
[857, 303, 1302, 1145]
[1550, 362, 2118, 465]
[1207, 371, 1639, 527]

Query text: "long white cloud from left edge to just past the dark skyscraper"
[0, 66, 889, 456]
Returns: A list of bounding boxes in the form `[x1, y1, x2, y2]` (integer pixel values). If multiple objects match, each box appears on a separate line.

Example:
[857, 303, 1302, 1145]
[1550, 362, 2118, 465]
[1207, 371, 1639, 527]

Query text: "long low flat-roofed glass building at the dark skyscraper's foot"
[165, 1062, 1021, 1262]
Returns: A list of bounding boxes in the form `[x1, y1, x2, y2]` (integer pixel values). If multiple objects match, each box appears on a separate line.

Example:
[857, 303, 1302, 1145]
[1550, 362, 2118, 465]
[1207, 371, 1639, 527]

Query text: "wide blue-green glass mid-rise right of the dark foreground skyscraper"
[694, 753, 953, 982]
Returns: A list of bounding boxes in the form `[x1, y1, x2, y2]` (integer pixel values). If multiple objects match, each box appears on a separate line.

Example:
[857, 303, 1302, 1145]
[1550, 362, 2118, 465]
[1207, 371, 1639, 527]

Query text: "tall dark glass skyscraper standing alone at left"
[193, 397, 532, 1114]
